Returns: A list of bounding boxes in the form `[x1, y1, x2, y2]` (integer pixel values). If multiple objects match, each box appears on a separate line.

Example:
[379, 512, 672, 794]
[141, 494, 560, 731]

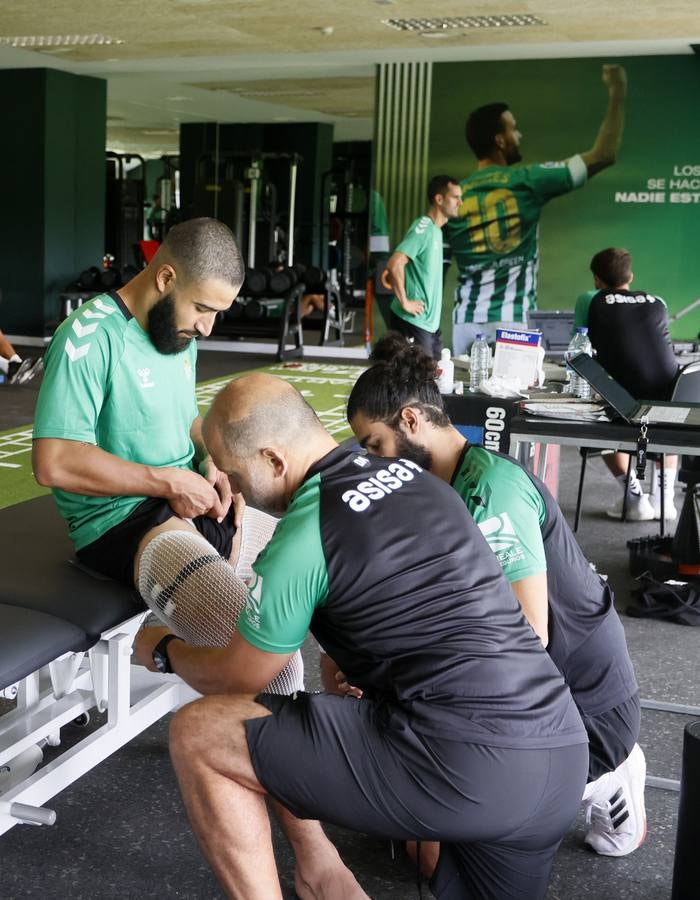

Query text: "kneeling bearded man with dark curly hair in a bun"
[348, 335, 646, 856]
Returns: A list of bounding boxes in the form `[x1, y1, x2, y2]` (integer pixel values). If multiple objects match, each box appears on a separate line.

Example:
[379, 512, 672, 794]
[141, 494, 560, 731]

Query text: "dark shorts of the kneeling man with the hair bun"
[581, 693, 642, 781]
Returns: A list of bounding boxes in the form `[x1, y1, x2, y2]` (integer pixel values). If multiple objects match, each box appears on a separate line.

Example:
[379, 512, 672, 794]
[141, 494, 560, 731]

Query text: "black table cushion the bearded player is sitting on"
[0, 496, 145, 642]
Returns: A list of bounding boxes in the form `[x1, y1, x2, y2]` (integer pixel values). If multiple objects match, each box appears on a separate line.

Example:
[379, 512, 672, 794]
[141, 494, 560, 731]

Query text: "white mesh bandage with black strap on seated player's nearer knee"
[139, 517, 304, 694]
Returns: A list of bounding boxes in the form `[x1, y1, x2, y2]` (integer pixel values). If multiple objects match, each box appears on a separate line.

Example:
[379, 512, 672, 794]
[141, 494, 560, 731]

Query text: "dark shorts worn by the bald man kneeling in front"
[245, 692, 587, 900]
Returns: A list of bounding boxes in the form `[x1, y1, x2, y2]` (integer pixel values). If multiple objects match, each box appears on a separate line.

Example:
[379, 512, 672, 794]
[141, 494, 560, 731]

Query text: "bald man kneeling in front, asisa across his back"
[137, 375, 587, 900]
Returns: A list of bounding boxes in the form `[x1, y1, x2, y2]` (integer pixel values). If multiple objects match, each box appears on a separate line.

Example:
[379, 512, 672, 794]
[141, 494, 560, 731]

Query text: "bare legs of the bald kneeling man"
[170, 696, 368, 900]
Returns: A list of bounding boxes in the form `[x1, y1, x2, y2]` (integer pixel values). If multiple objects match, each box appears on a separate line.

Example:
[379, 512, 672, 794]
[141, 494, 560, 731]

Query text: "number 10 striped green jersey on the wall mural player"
[445, 156, 588, 324]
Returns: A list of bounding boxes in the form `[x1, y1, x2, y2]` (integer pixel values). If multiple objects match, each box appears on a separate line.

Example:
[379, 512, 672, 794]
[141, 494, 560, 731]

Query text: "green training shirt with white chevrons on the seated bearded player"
[34, 293, 199, 550]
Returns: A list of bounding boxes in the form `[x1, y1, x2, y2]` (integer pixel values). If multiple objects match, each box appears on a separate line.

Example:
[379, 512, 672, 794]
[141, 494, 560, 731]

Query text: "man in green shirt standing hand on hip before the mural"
[385, 175, 462, 359]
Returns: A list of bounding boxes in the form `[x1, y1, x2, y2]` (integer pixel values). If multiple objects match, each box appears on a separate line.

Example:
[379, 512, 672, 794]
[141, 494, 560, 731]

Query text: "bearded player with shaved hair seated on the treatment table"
[32, 218, 244, 587]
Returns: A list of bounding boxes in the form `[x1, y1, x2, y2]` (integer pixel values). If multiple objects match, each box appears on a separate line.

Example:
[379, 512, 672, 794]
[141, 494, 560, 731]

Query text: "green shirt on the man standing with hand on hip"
[391, 216, 442, 334]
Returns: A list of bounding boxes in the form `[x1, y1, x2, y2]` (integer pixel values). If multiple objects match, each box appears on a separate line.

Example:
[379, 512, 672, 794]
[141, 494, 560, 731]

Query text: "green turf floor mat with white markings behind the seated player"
[0, 363, 363, 509]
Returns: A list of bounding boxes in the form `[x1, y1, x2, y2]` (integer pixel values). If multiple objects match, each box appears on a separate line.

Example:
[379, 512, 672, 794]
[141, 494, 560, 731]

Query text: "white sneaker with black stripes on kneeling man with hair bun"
[584, 744, 647, 856]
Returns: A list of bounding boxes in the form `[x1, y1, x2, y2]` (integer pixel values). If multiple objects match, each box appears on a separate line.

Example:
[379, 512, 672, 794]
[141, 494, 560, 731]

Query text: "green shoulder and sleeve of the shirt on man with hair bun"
[452, 444, 547, 582]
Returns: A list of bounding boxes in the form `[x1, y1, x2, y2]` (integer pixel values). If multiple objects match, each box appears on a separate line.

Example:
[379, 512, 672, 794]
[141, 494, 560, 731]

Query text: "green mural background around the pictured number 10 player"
[429, 55, 700, 338]
